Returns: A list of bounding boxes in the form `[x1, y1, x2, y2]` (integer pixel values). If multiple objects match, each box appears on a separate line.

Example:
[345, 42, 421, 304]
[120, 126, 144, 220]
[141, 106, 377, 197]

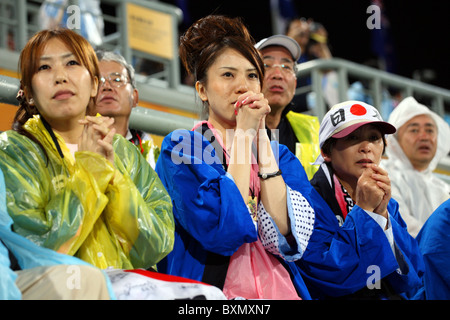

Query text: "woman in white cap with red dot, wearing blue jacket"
[298, 101, 423, 299]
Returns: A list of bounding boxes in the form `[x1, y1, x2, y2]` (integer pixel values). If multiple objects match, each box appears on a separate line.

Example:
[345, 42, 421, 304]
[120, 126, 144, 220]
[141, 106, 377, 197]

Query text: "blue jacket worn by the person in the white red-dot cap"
[306, 168, 425, 299]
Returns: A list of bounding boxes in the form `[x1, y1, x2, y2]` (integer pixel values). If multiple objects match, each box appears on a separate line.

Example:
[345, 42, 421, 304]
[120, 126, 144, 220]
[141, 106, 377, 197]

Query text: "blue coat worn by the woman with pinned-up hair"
[156, 130, 310, 299]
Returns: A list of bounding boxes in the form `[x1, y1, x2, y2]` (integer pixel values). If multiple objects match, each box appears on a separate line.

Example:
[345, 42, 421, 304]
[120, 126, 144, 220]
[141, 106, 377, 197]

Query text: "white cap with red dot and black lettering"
[315, 101, 396, 164]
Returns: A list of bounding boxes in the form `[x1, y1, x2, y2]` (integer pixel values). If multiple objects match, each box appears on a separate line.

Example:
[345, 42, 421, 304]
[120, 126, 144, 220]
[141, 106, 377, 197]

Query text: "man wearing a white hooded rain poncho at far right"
[381, 97, 450, 237]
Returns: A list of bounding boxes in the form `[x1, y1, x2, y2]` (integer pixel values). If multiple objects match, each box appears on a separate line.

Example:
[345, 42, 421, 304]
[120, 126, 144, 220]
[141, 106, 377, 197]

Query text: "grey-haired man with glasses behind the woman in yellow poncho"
[96, 51, 157, 168]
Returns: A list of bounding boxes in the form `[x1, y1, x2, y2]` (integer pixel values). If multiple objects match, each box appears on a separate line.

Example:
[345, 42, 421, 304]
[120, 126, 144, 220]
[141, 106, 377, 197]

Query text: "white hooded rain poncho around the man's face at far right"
[381, 97, 450, 237]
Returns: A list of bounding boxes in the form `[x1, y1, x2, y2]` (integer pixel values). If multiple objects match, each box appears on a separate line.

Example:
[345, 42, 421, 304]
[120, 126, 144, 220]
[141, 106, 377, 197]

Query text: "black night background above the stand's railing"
[161, 0, 450, 89]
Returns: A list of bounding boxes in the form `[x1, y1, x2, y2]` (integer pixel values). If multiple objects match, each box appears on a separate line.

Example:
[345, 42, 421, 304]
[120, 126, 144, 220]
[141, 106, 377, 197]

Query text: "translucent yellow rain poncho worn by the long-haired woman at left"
[0, 116, 174, 269]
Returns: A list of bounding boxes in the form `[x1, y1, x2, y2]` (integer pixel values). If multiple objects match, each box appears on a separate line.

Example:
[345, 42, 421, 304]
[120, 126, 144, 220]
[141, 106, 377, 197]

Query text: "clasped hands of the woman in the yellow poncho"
[78, 116, 116, 165]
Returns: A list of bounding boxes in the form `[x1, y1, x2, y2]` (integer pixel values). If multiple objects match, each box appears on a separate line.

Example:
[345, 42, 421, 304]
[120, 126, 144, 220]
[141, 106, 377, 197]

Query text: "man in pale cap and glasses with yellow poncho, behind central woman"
[255, 35, 320, 177]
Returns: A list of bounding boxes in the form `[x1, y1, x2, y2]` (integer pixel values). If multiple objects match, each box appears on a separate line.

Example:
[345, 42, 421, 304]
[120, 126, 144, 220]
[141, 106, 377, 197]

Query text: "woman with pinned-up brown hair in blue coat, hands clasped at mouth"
[156, 16, 314, 299]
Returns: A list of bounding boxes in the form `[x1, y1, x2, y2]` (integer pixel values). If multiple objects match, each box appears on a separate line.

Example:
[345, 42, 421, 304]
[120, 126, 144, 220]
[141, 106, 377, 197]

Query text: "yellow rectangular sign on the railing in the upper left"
[127, 3, 174, 59]
